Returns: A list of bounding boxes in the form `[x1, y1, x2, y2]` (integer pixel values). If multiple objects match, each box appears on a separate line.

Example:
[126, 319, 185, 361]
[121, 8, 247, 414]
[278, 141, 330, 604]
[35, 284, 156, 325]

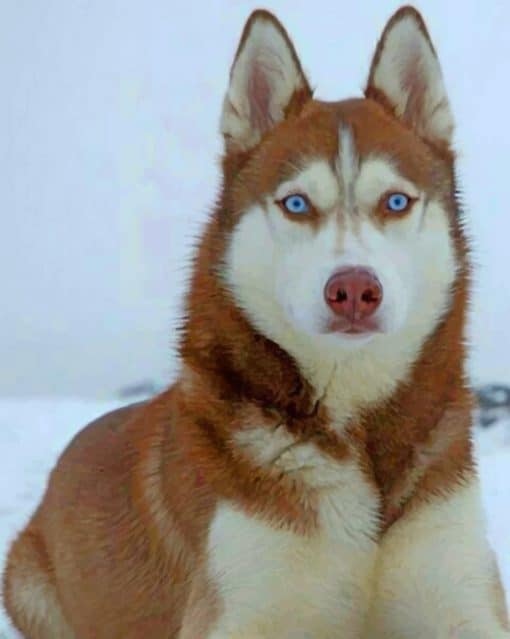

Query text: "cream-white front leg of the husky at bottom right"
[366, 480, 510, 639]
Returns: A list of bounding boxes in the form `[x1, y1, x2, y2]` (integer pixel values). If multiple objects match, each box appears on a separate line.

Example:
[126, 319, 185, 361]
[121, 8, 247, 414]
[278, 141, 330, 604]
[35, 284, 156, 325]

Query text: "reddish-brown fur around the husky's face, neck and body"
[0, 6, 498, 639]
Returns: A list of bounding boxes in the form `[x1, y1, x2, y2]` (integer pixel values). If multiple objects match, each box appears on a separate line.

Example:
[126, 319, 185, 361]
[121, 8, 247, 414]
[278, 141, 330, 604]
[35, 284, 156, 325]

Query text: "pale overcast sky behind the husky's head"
[0, 0, 510, 395]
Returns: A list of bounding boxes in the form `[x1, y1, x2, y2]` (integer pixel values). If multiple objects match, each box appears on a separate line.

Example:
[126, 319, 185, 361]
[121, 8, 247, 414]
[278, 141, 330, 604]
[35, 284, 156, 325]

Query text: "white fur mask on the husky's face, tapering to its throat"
[224, 151, 456, 425]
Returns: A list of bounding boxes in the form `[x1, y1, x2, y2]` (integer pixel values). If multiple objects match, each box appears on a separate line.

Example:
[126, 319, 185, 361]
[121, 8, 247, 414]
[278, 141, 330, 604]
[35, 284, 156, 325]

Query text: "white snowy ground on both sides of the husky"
[0, 399, 510, 639]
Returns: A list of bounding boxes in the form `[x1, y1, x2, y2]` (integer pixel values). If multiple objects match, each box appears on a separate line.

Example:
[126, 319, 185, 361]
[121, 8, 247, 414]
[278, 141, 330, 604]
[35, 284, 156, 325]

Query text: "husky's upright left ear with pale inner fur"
[221, 10, 312, 151]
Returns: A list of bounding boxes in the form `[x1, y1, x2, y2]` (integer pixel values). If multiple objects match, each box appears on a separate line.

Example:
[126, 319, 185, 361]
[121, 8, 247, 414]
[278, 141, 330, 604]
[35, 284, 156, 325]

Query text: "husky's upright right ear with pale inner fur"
[365, 7, 453, 145]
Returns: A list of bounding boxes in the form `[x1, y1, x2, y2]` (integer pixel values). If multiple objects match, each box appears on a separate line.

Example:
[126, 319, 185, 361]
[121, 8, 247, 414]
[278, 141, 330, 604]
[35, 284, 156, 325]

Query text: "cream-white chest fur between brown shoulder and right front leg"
[208, 444, 379, 639]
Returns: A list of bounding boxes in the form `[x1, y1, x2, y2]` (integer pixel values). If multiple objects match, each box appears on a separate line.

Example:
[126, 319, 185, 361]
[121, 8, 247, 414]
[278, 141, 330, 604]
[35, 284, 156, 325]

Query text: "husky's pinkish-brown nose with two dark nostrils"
[324, 266, 383, 322]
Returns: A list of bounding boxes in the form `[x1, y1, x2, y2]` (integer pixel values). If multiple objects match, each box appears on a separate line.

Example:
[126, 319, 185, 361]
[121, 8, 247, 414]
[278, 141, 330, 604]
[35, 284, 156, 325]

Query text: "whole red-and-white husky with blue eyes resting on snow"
[4, 7, 510, 639]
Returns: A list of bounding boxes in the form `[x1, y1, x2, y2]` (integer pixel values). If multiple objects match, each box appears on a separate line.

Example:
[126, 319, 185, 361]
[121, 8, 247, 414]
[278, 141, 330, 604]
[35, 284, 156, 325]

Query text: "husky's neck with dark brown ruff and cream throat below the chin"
[180, 212, 472, 521]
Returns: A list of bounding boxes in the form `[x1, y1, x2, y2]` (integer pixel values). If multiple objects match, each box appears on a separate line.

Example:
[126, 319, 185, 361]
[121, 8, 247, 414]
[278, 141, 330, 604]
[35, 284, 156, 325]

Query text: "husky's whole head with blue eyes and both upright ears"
[219, 9, 456, 356]
